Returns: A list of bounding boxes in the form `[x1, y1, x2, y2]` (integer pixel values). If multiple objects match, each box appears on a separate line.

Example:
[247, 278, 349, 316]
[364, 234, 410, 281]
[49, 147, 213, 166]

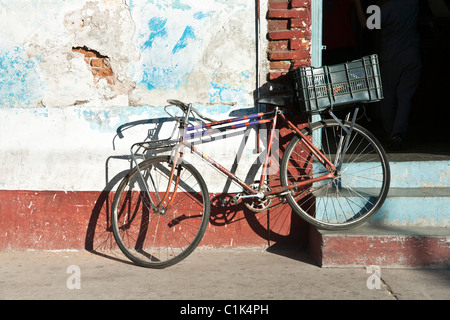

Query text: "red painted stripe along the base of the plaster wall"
[0, 191, 307, 251]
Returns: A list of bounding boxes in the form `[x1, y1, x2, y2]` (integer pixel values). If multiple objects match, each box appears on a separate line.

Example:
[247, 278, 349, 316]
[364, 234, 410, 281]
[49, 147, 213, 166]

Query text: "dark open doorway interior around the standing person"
[323, 0, 450, 156]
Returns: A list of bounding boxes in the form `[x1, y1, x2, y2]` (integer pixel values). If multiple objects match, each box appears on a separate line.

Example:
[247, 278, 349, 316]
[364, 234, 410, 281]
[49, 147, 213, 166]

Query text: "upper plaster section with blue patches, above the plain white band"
[0, 0, 256, 107]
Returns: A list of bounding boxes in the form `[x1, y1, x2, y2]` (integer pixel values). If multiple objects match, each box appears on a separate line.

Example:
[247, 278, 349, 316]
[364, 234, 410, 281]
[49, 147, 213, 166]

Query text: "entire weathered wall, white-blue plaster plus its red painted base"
[0, 0, 314, 249]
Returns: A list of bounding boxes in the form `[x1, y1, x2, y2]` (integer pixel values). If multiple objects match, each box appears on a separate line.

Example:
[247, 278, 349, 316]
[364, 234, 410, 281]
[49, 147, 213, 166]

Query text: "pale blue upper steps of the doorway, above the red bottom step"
[316, 157, 450, 227]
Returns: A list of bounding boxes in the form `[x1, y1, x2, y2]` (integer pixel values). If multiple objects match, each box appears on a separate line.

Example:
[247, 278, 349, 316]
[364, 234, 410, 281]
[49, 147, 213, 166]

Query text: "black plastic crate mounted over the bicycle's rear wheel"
[292, 54, 383, 113]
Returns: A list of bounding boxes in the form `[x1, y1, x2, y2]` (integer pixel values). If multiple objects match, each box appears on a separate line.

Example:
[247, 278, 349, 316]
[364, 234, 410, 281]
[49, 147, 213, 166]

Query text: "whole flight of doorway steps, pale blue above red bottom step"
[308, 155, 450, 268]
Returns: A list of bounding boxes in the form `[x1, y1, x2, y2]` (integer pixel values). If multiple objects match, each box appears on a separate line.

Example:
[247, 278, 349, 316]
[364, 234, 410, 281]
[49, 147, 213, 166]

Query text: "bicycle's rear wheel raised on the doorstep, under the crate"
[280, 120, 390, 230]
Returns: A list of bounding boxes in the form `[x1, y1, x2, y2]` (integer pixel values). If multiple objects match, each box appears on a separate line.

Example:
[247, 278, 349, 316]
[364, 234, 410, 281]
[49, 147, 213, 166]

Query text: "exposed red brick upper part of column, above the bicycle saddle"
[267, 0, 311, 81]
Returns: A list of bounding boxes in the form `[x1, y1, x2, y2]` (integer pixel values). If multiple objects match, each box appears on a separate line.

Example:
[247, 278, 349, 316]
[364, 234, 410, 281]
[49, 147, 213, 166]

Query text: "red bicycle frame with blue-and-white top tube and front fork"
[149, 108, 336, 208]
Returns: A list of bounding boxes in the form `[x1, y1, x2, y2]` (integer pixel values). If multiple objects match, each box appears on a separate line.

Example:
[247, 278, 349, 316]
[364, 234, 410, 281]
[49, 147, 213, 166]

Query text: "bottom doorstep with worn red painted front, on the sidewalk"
[309, 224, 450, 268]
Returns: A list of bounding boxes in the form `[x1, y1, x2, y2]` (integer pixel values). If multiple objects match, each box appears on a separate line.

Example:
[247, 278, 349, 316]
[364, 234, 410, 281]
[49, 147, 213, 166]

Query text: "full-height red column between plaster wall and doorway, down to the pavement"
[253, 0, 312, 246]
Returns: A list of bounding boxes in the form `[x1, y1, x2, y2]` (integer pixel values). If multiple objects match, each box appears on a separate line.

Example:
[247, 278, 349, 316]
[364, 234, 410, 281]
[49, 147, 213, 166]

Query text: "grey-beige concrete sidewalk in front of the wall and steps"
[0, 248, 450, 300]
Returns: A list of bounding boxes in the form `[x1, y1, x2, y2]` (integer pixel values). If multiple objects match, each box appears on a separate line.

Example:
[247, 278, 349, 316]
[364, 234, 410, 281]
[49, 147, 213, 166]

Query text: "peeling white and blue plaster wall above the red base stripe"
[0, 0, 265, 192]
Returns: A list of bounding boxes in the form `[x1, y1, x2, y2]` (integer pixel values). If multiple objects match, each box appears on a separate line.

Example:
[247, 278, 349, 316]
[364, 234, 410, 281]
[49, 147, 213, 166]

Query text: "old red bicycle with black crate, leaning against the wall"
[111, 55, 390, 268]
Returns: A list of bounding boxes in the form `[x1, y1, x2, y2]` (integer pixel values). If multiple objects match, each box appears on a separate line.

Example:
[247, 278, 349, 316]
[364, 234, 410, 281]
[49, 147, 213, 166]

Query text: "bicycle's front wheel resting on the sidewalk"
[111, 156, 210, 268]
